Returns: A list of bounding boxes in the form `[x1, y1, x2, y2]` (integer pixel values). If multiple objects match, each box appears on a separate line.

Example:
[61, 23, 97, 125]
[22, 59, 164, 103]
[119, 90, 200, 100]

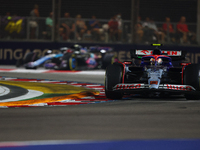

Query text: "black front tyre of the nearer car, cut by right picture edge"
[183, 64, 200, 100]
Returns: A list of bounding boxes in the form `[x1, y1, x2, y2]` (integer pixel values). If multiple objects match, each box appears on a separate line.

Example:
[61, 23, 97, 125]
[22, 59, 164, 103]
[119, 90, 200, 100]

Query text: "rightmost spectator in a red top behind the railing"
[176, 16, 196, 44]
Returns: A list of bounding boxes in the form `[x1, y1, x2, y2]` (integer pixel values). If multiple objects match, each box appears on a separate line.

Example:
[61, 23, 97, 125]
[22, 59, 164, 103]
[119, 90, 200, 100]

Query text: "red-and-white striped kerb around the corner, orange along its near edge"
[0, 77, 113, 108]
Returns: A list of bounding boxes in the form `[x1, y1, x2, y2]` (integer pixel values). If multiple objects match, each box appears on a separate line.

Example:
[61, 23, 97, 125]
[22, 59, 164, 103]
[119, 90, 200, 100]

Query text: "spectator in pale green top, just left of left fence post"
[45, 12, 53, 39]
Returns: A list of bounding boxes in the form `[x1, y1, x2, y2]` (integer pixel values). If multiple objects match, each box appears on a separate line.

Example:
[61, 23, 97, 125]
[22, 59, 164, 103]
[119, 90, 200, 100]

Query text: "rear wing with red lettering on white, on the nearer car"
[130, 49, 187, 60]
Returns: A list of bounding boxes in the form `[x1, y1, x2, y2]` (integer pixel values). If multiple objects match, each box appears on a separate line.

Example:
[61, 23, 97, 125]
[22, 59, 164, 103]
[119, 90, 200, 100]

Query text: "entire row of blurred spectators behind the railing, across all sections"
[0, 5, 197, 44]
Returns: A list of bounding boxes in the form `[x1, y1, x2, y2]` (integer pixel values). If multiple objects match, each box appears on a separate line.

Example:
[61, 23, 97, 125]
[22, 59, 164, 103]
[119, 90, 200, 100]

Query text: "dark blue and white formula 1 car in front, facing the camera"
[105, 44, 200, 100]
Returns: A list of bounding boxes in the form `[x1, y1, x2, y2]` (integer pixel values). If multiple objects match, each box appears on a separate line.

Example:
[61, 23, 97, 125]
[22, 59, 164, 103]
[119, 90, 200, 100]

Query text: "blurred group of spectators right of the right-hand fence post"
[135, 16, 197, 44]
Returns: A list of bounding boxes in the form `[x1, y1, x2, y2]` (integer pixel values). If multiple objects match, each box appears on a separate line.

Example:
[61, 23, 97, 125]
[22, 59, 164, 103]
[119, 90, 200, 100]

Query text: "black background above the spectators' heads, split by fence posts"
[0, 0, 197, 22]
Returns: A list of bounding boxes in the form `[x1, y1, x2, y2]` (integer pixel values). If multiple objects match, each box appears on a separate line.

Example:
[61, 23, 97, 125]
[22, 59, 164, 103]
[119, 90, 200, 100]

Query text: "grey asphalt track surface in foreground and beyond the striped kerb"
[0, 66, 200, 141]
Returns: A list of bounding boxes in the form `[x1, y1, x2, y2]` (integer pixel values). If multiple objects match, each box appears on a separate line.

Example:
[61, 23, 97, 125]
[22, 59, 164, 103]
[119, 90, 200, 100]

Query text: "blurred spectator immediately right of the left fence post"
[60, 12, 75, 41]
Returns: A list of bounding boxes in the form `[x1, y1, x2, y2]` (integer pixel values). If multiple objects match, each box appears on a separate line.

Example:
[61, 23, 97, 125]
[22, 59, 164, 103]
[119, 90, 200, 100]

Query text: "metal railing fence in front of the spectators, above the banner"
[0, 16, 198, 46]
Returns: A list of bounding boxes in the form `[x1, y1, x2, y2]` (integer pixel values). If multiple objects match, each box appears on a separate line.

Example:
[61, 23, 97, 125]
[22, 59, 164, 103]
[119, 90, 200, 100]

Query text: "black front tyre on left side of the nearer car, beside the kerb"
[105, 64, 123, 99]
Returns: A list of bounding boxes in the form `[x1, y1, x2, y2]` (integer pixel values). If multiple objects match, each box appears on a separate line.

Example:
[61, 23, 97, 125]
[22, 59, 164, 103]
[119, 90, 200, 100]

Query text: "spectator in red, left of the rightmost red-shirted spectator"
[162, 17, 176, 43]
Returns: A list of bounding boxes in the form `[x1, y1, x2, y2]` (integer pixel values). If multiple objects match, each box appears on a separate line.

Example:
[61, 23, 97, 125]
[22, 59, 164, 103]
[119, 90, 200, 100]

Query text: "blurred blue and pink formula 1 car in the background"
[16, 44, 118, 70]
